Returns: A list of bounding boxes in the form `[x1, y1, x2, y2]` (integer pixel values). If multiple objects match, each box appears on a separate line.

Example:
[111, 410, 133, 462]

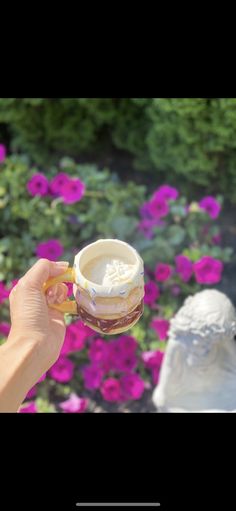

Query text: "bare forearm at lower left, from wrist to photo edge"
[0, 338, 38, 412]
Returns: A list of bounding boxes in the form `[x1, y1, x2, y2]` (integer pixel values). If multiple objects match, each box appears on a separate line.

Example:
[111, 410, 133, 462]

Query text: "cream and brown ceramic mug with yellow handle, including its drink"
[44, 239, 144, 335]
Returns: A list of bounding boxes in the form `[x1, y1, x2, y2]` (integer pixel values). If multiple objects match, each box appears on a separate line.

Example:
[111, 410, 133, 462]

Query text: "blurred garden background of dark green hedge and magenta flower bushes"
[0, 98, 236, 413]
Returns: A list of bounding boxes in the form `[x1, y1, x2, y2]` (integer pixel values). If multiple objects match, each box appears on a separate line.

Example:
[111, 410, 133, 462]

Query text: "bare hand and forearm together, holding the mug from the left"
[0, 259, 68, 412]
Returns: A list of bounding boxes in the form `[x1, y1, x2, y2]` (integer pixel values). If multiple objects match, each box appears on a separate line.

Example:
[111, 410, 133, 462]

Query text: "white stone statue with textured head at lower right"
[153, 289, 236, 413]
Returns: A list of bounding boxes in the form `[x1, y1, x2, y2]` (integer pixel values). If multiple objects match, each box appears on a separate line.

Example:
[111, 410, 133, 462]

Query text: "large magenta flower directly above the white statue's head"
[193, 256, 223, 284]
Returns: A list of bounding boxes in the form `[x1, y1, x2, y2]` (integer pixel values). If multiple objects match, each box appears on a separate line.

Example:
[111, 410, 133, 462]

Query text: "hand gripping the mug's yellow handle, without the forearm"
[7, 259, 69, 377]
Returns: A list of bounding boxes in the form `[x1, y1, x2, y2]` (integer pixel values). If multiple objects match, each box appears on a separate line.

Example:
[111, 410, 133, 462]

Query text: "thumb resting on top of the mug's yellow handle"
[23, 259, 69, 288]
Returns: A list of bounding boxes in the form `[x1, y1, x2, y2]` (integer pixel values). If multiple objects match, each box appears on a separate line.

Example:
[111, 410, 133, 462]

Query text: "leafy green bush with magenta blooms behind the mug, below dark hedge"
[0, 155, 232, 412]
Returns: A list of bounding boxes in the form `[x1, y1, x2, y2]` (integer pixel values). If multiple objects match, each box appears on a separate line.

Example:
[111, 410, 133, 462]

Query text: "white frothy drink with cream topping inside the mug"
[83, 256, 134, 286]
